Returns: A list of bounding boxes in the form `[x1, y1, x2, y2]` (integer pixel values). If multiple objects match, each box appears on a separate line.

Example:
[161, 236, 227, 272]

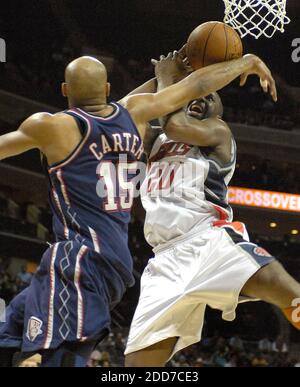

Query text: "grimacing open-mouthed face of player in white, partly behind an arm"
[187, 93, 223, 120]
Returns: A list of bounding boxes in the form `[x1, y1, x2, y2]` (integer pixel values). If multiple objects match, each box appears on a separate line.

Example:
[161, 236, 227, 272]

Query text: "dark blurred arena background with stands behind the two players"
[0, 0, 300, 367]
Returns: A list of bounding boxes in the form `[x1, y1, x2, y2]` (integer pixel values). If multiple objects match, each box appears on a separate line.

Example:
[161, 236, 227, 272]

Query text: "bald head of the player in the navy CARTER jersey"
[62, 56, 110, 107]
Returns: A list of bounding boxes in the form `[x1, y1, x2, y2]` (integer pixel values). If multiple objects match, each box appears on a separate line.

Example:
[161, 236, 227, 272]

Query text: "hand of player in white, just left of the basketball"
[151, 51, 188, 82]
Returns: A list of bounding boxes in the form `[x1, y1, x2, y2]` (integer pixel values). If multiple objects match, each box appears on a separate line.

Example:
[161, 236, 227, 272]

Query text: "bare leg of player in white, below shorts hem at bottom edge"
[125, 337, 178, 367]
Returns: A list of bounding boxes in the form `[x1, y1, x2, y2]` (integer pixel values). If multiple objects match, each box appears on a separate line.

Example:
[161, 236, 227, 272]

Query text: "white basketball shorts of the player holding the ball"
[125, 222, 275, 356]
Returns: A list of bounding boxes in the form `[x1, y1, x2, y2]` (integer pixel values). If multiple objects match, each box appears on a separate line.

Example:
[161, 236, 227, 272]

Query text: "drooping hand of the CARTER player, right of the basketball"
[240, 55, 277, 102]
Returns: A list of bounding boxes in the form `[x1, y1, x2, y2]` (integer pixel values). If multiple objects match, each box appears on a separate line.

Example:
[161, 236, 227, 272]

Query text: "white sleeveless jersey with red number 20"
[141, 134, 236, 247]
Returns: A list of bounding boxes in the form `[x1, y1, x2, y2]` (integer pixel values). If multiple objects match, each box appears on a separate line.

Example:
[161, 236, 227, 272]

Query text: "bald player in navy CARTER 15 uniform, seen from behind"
[0, 55, 276, 366]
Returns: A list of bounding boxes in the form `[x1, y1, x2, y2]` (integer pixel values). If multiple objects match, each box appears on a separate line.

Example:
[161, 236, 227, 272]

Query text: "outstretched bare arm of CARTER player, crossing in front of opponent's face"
[121, 55, 276, 132]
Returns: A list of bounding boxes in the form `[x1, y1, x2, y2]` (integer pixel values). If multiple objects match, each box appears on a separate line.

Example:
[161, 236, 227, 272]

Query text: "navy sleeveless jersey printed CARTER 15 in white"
[48, 103, 143, 285]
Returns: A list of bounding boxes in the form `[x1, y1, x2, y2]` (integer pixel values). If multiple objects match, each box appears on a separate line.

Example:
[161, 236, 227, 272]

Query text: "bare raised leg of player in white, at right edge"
[241, 261, 300, 330]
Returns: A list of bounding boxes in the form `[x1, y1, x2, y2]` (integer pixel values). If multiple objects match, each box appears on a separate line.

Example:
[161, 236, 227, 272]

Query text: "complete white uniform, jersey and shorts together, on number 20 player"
[125, 135, 274, 359]
